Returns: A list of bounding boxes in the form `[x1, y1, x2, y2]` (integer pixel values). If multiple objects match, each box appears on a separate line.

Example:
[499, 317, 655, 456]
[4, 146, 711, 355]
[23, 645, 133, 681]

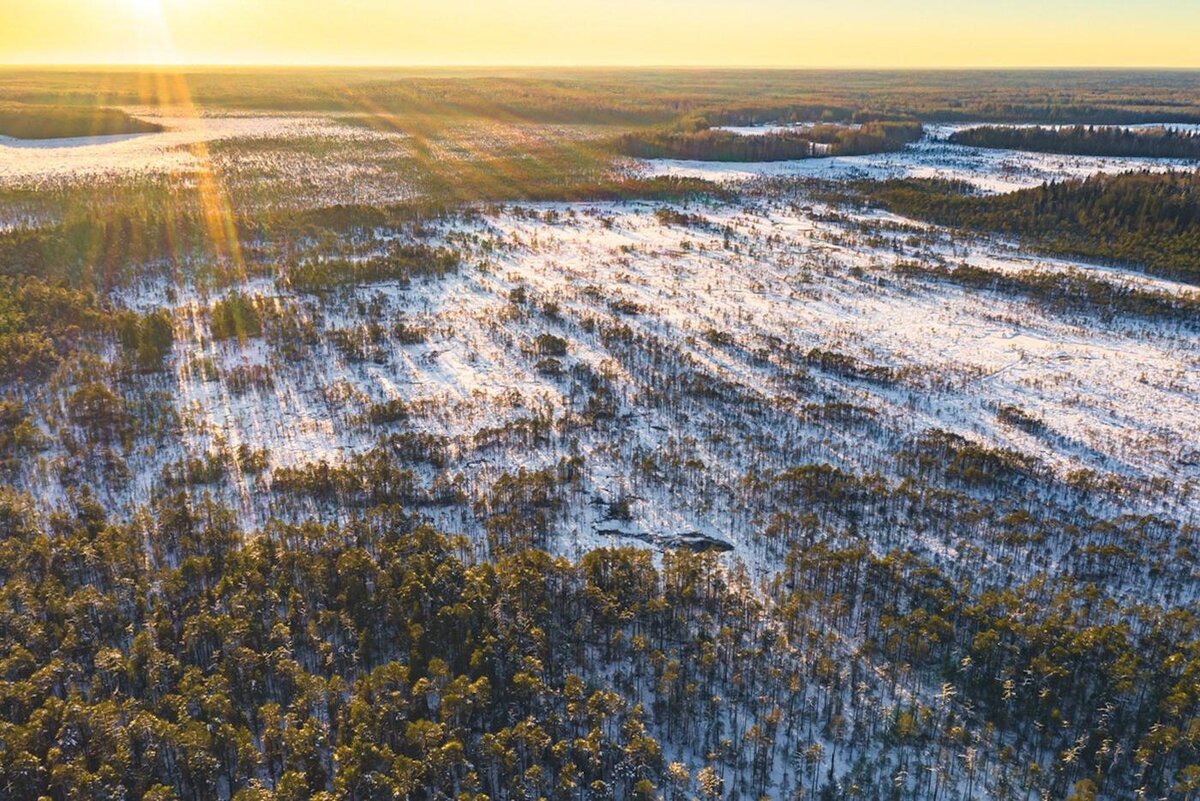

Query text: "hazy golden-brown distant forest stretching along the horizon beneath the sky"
[7, 68, 1200, 126]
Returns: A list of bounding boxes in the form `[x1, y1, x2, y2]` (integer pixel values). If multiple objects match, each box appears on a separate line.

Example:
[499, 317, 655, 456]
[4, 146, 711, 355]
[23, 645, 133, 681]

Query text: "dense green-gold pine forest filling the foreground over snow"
[0, 490, 1200, 801]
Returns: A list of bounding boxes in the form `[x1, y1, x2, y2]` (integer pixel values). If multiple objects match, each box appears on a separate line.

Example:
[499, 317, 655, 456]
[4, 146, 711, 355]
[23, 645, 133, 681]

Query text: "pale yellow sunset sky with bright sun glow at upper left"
[0, 0, 1200, 67]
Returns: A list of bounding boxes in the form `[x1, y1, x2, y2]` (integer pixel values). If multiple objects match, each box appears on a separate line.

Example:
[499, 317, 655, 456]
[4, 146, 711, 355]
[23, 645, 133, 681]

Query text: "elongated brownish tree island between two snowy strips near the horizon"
[614, 122, 923, 162]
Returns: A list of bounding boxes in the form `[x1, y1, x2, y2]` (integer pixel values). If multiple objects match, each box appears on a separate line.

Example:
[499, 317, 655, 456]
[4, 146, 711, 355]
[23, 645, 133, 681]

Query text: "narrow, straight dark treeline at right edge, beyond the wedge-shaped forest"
[949, 125, 1200, 158]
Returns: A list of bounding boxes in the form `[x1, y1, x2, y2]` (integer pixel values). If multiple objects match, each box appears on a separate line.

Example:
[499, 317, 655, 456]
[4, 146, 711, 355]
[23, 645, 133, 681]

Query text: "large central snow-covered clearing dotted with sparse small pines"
[14, 191, 1200, 606]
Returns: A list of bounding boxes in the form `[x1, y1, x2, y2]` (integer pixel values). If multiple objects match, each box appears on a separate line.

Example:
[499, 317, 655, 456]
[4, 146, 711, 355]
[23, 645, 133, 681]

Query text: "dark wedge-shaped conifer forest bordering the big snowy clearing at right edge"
[839, 173, 1200, 283]
